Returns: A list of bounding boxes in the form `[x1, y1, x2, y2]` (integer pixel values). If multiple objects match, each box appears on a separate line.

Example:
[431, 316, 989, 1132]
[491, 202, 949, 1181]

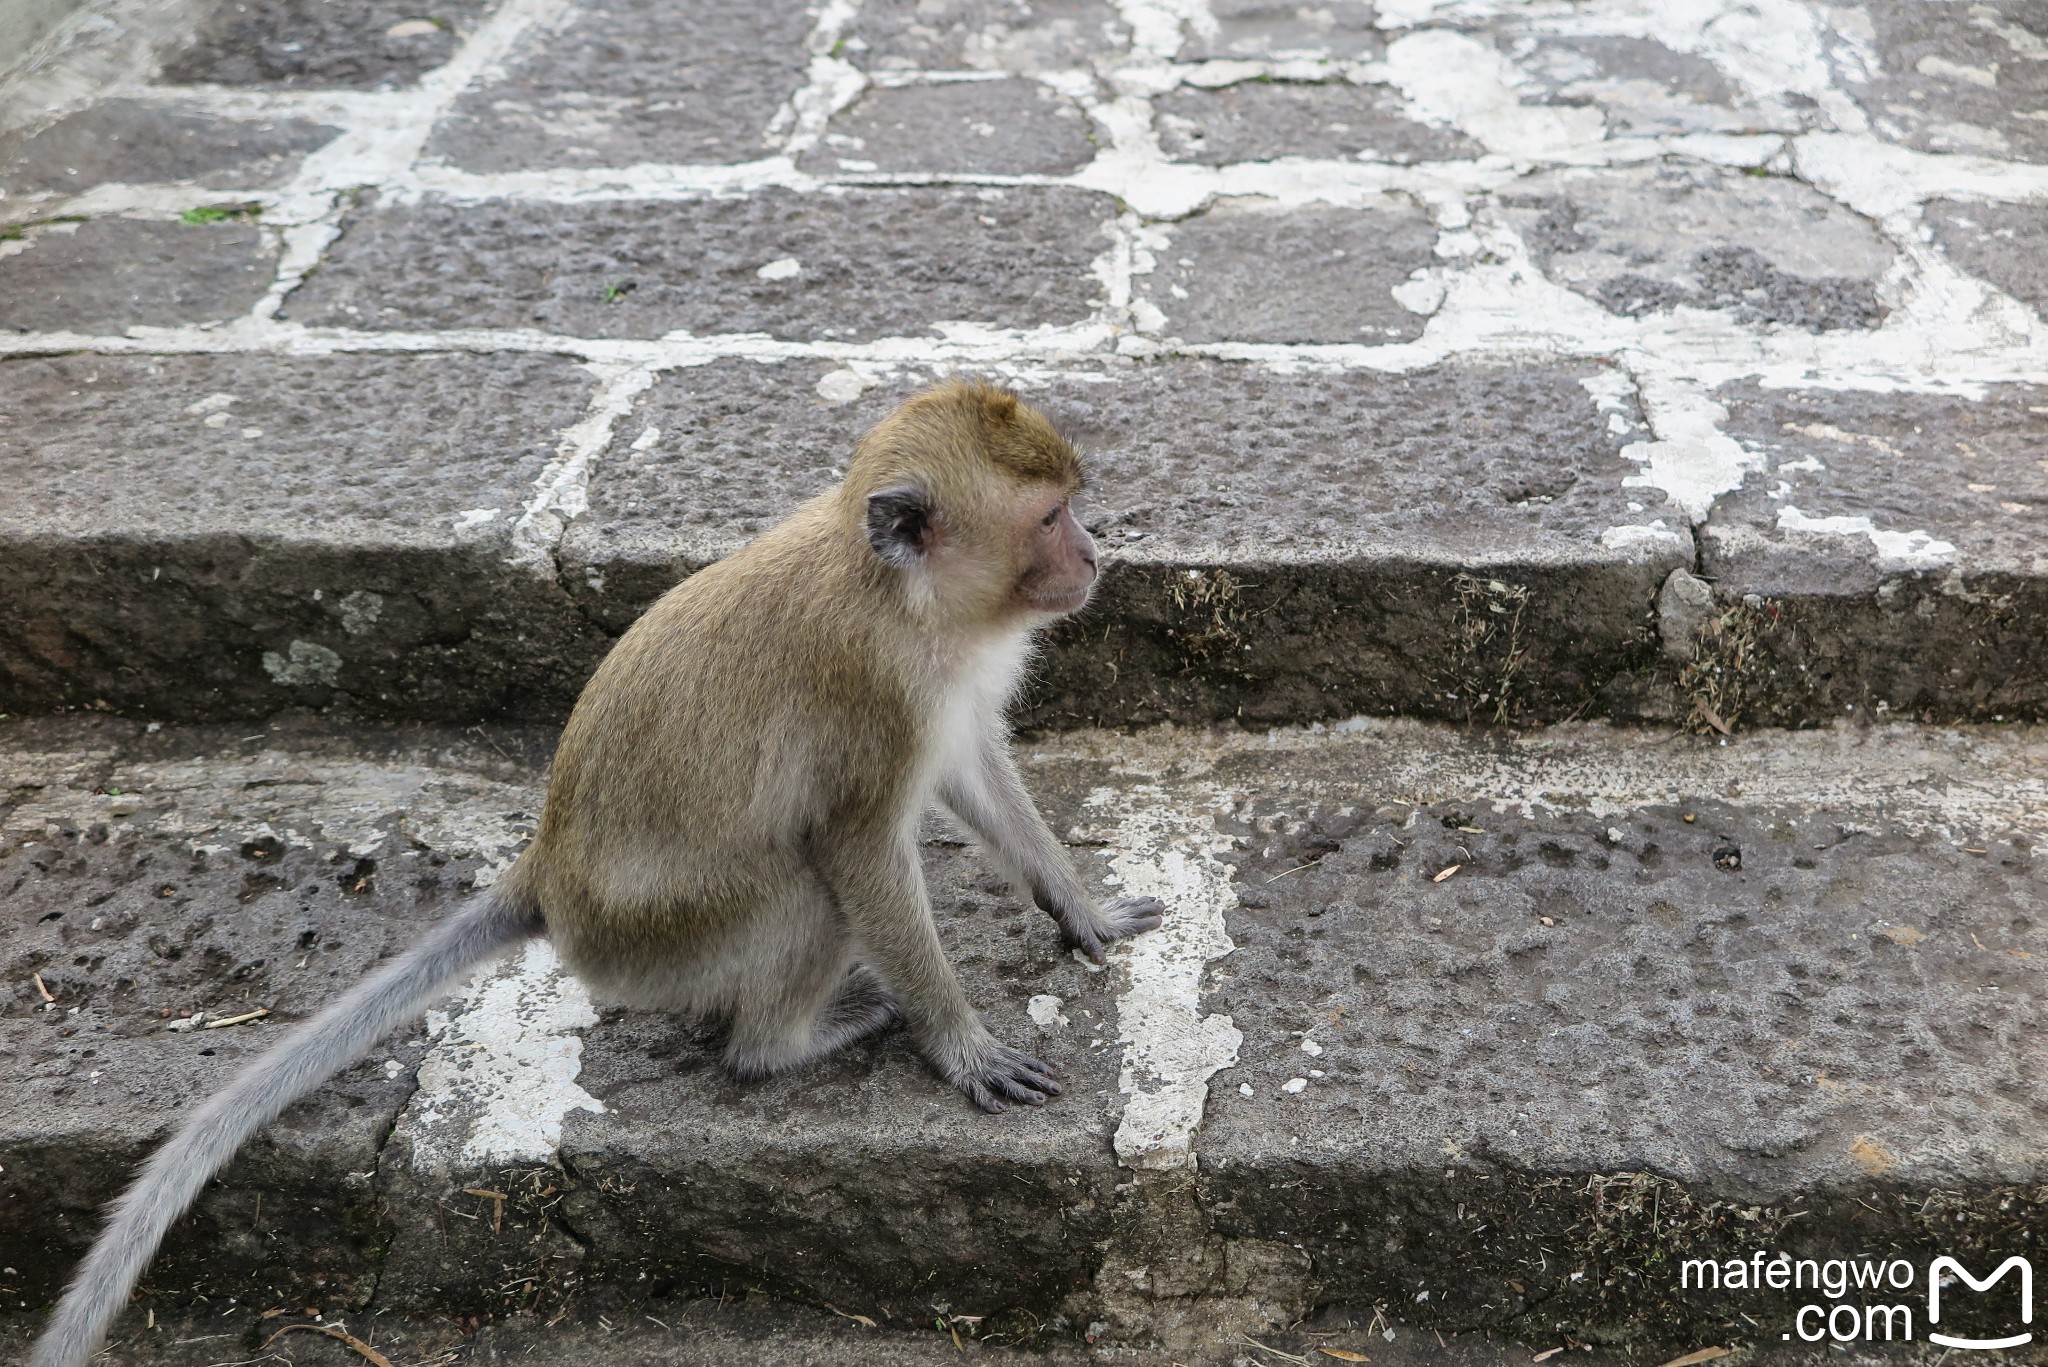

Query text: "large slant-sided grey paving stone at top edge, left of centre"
[426, 0, 811, 172]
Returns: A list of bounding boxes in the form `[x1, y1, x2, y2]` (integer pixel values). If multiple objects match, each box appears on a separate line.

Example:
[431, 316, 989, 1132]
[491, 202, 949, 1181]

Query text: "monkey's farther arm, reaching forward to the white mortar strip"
[938, 734, 1165, 963]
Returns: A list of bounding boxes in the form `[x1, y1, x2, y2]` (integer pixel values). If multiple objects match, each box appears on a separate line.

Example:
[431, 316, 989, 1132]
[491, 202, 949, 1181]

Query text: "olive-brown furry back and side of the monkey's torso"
[508, 494, 915, 986]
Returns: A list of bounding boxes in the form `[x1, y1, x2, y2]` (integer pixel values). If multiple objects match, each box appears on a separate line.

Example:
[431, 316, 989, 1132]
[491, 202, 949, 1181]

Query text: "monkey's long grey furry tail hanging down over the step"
[29, 892, 543, 1367]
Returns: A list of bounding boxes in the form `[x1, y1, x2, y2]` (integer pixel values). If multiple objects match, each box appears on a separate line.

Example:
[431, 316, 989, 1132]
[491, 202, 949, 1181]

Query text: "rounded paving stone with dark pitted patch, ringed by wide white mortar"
[1501, 162, 1894, 332]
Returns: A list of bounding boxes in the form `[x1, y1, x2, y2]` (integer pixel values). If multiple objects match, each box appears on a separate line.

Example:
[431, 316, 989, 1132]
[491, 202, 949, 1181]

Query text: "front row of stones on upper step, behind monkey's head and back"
[0, 355, 2048, 730]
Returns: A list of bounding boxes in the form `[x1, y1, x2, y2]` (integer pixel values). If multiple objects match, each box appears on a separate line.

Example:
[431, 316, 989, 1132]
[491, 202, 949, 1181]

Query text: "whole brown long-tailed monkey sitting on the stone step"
[31, 379, 1165, 1367]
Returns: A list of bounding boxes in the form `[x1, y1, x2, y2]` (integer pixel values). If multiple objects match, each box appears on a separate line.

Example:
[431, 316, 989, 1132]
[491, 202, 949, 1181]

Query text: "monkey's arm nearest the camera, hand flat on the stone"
[817, 830, 1061, 1111]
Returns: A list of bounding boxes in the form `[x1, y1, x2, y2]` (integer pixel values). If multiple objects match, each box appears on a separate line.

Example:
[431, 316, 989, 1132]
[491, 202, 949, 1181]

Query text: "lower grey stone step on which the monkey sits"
[0, 717, 2048, 1361]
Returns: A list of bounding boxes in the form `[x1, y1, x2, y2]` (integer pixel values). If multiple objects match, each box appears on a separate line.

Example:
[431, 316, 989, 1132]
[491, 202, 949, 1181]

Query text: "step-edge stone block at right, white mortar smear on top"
[1700, 383, 2048, 721]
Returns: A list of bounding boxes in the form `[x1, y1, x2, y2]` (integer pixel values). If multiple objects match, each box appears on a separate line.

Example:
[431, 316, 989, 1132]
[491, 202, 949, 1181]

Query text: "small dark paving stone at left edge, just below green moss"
[0, 219, 276, 334]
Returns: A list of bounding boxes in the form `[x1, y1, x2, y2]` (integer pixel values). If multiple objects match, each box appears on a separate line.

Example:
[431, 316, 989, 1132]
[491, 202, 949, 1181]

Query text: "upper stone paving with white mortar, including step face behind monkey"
[0, 0, 2048, 730]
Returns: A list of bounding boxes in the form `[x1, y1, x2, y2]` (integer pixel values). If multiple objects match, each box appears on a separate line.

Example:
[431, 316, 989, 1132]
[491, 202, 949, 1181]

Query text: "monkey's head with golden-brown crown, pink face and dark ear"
[844, 379, 1096, 625]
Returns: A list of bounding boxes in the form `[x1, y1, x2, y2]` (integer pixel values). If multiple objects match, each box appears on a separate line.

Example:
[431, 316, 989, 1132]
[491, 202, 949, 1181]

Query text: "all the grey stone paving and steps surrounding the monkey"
[0, 0, 2048, 1367]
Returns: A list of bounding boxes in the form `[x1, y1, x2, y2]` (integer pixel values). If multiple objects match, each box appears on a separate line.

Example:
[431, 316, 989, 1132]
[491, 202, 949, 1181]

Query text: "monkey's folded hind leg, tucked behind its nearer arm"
[725, 887, 901, 1078]
